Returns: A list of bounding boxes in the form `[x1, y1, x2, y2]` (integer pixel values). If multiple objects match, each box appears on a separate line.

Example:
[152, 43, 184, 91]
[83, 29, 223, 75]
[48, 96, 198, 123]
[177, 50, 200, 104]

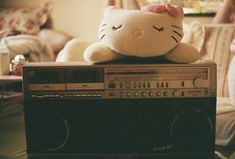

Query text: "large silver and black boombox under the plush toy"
[23, 61, 216, 159]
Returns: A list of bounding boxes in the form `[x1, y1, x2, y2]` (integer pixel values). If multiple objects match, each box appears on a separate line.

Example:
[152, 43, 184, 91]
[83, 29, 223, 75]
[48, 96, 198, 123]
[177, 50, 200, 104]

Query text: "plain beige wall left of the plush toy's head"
[0, 0, 104, 41]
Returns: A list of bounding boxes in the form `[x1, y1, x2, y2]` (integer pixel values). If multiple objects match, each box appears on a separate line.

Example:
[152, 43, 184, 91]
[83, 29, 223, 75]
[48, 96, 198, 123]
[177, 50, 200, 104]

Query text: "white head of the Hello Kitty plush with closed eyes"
[99, 6, 183, 57]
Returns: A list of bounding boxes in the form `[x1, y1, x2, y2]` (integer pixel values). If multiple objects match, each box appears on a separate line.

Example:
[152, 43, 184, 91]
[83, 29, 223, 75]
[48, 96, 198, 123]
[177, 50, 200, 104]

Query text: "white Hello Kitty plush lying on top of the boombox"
[84, 4, 200, 63]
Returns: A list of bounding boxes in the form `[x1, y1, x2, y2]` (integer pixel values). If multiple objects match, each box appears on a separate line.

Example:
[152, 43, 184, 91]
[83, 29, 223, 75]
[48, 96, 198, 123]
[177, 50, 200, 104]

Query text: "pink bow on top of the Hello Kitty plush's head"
[141, 4, 183, 17]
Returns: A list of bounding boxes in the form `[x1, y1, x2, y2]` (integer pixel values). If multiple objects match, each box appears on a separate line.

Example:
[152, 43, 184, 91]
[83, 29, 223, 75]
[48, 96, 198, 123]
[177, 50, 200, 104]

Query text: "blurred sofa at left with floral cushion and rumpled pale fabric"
[0, 2, 72, 62]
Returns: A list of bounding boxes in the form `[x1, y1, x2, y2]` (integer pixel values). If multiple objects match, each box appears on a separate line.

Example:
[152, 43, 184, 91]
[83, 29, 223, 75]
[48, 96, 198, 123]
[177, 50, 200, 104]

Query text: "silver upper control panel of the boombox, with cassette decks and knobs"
[23, 61, 216, 99]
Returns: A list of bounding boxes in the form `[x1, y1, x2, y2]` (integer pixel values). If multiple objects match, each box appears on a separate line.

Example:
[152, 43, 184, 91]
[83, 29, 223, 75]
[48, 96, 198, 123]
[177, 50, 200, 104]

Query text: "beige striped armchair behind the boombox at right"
[185, 22, 235, 151]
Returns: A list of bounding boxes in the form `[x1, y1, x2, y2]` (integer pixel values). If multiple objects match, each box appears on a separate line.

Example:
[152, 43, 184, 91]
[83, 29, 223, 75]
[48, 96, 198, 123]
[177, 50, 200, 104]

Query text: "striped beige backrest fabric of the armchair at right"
[201, 24, 235, 97]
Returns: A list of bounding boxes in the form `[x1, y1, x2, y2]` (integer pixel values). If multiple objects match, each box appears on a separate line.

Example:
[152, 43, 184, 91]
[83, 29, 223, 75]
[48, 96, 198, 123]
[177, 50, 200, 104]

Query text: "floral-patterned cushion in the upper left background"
[0, 3, 52, 34]
